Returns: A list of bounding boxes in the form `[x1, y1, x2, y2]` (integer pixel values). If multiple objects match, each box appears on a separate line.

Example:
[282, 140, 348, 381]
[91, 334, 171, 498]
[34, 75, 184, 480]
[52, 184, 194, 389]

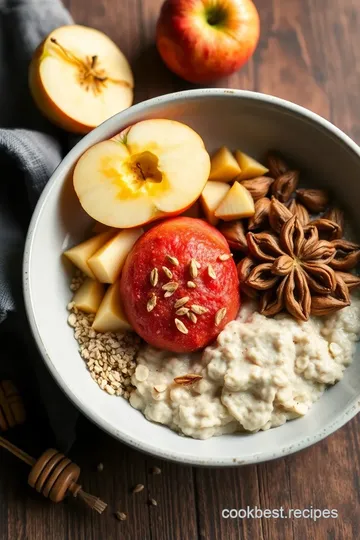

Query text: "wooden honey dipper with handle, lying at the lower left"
[0, 436, 107, 514]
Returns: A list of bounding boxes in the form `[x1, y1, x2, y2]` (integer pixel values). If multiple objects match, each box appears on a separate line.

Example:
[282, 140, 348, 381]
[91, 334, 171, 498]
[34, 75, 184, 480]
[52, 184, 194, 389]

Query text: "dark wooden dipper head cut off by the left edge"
[0, 381, 26, 431]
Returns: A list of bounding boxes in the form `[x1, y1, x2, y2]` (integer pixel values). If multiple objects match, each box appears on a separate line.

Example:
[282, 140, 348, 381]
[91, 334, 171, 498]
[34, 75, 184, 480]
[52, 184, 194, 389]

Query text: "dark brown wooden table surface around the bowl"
[0, 0, 360, 540]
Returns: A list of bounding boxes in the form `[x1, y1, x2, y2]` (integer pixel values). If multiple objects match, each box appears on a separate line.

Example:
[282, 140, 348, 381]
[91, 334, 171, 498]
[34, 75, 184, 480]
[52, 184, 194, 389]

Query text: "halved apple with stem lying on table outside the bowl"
[29, 25, 134, 133]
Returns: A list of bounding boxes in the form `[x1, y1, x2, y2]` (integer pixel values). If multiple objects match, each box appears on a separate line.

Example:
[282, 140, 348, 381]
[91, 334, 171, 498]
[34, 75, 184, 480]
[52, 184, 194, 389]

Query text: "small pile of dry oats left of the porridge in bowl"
[67, 272, 140, 399]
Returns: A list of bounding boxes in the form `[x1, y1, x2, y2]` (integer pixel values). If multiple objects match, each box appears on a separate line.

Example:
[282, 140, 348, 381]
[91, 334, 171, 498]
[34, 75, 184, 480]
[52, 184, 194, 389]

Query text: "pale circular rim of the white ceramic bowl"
[22, 88, 360, 467]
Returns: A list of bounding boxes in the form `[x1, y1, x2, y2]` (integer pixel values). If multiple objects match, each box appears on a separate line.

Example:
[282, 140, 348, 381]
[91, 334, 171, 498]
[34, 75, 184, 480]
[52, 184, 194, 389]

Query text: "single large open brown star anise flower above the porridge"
[239, 216, 349, 321]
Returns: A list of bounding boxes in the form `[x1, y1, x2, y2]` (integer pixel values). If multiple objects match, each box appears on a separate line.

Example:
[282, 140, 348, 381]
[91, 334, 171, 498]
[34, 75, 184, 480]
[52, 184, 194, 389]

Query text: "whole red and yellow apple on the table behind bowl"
[156, 0, 260, 84]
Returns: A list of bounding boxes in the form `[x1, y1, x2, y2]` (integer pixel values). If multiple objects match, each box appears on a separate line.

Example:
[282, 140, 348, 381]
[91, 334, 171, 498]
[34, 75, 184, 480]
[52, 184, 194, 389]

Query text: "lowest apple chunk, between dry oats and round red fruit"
[92, 281, 131, 332]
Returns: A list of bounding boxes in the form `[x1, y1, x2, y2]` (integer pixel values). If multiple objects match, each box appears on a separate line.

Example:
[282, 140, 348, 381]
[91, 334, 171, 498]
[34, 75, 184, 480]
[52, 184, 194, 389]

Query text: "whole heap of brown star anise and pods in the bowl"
[220, 152, 360, 320]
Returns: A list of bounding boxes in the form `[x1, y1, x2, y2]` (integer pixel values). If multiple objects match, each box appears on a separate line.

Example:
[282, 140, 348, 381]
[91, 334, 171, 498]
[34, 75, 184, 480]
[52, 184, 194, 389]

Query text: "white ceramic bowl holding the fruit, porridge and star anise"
[24, 89, 360, 466]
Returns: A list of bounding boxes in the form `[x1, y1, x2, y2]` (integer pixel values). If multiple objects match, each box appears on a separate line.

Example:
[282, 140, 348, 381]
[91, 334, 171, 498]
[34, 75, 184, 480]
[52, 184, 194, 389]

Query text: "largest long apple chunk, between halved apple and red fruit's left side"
[88, 229, 144, 283]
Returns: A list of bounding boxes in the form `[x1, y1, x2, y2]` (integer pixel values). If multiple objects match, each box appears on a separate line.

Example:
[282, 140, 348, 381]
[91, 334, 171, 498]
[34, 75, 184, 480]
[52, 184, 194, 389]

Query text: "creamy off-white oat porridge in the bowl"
[130, 295, 360, 439]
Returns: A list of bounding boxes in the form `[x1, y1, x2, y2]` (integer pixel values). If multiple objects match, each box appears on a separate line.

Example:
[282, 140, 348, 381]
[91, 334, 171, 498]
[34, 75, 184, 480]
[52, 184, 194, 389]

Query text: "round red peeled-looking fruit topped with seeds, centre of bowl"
[120, 217, 240, 352]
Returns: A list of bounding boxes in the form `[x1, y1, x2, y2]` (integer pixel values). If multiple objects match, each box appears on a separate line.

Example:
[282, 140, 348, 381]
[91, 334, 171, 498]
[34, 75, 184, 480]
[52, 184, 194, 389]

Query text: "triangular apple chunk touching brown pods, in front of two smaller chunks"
[215, 182, 255, 221]
